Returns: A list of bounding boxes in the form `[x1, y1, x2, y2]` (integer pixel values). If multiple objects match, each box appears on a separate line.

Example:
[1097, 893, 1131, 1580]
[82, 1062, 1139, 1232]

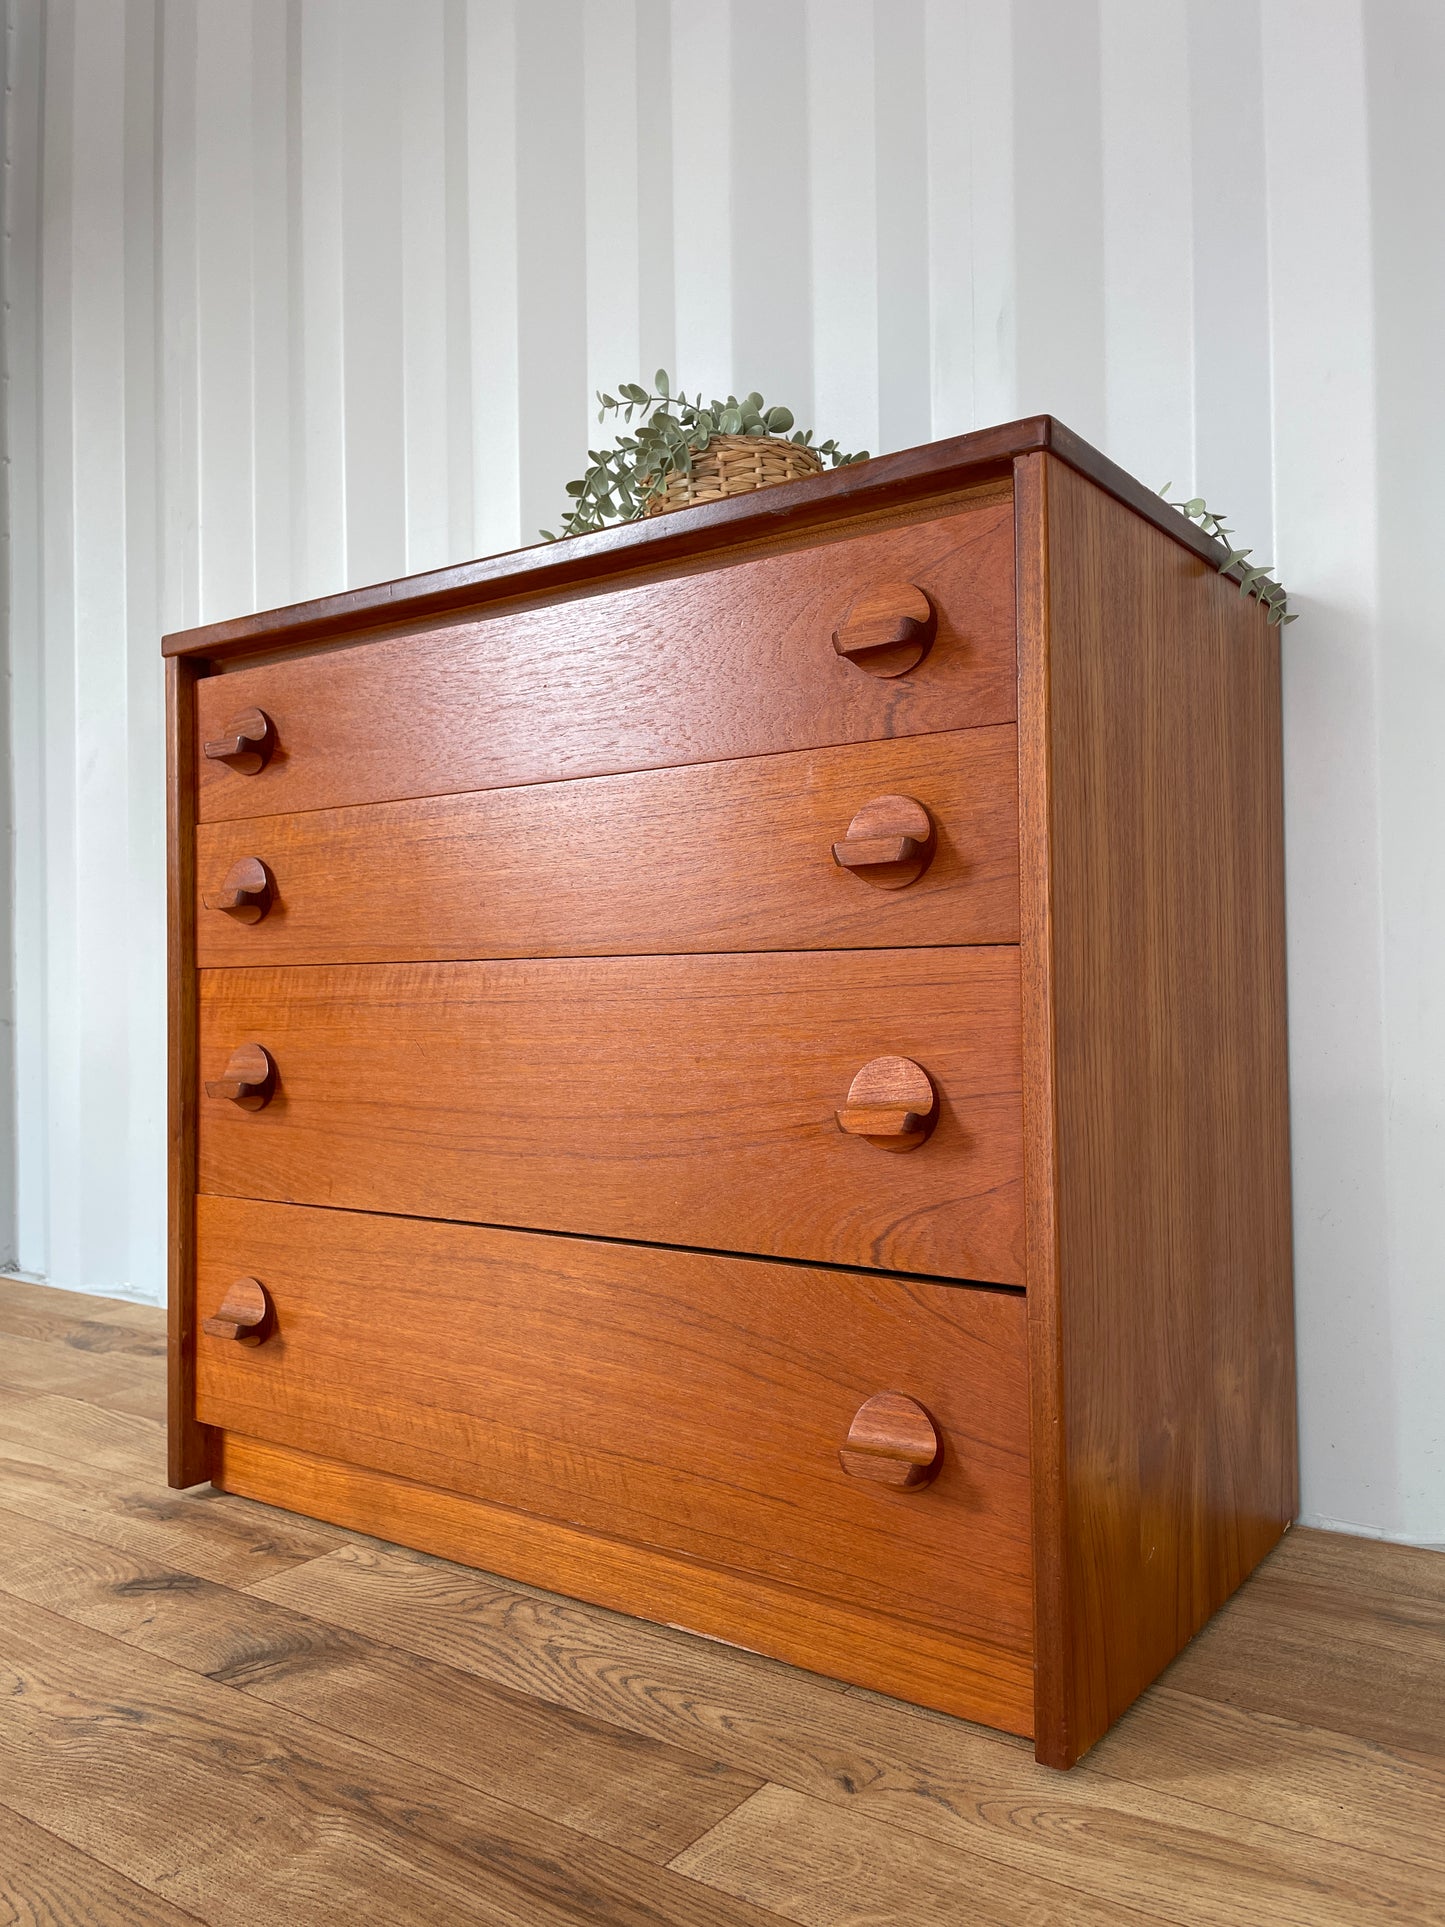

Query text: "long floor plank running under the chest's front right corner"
[254, 1545, 1445, 1927]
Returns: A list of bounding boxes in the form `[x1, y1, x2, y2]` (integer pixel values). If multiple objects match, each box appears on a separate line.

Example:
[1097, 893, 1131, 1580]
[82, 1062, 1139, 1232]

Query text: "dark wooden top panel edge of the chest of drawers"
[162, 414, 1223, 661]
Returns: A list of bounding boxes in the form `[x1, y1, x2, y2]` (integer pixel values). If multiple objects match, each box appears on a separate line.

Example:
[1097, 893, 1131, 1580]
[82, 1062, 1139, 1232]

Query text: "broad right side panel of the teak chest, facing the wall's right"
[1044, 457, 1297, 1757]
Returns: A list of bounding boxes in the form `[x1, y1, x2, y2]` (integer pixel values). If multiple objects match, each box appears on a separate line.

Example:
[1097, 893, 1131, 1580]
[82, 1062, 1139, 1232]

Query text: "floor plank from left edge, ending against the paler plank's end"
[0, 1509, 759, 1865]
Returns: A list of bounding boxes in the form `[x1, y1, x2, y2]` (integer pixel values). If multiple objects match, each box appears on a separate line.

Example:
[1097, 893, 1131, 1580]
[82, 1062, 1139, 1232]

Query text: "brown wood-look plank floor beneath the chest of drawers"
[0, 1281, 1445, 1927]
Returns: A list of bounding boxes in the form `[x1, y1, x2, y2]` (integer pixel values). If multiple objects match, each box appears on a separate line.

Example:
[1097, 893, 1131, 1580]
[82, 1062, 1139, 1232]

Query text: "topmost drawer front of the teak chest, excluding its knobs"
[197, 499, 1015, 821]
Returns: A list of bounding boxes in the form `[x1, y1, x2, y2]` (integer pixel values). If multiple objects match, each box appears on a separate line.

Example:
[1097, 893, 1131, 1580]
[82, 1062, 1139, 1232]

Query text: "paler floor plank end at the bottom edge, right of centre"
[672, 1786, 1158, 1927]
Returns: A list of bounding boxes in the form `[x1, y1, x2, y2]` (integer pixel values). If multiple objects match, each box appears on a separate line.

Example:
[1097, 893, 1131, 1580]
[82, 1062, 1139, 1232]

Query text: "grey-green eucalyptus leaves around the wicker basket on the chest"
[541, 368, 867, 541]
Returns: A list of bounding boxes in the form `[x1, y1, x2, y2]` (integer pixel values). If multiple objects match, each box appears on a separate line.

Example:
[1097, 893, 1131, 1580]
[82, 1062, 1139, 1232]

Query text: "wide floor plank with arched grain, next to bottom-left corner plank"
[0, 1594, 793, 1927]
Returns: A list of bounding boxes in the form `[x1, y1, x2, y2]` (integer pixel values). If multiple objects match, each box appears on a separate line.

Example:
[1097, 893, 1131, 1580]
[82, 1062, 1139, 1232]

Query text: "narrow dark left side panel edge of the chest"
[166, 657, 210, 1486]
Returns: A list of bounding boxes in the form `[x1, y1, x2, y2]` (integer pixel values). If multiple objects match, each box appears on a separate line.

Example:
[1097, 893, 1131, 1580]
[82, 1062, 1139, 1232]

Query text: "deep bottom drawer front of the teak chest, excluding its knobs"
[197, 1197, 1031, 1650]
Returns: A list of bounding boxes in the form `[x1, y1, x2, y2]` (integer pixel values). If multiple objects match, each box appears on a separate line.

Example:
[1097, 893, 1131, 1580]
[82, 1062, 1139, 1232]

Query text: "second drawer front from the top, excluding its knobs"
[197, 725, 1019, 965]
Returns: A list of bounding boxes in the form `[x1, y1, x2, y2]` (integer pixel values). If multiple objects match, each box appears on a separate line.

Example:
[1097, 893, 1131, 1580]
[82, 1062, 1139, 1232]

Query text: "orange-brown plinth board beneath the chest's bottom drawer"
[216, 1432, 1033, 1734]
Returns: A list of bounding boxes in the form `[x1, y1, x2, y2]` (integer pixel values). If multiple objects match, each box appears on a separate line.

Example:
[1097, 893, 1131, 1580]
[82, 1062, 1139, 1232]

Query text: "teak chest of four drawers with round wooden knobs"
[164, 418, 1295, 1765]
